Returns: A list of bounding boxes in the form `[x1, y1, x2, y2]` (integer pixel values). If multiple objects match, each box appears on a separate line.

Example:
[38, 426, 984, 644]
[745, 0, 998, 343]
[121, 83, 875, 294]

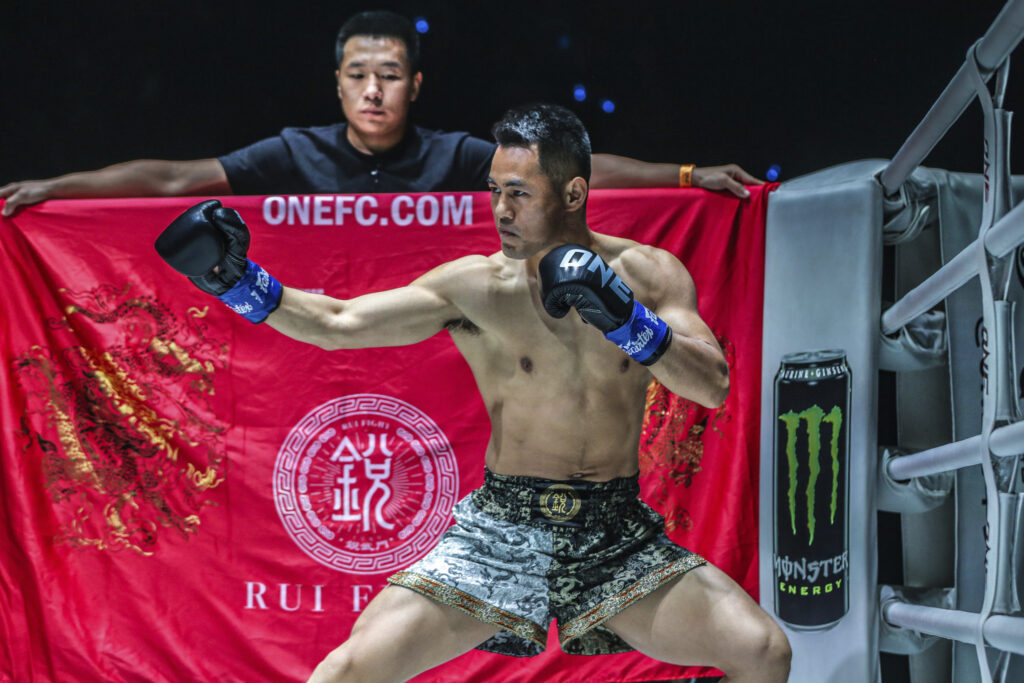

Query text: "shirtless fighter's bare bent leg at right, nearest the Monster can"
[605, 564, 790, 681]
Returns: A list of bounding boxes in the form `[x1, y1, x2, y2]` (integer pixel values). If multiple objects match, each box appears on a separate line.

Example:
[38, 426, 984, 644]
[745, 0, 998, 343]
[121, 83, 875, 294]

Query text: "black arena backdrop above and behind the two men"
[0, 0, 1022, 184]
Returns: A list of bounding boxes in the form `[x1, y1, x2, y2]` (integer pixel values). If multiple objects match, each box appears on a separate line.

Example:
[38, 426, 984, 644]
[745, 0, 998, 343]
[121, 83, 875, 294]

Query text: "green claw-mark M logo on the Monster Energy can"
[778, 405, 843, 546]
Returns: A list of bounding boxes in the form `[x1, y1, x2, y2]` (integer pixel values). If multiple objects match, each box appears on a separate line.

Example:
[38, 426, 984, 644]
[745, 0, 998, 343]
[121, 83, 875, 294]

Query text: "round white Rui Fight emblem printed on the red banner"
[273, 394, 459, 573]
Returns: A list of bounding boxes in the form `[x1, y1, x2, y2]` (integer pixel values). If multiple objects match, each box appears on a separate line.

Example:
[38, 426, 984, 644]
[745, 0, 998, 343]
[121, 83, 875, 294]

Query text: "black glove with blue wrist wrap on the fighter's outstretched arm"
[155, 200, 282, 323]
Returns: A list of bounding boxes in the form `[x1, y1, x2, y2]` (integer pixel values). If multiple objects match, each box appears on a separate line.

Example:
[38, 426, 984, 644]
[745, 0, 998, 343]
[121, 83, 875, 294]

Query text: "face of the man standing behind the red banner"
[335, 36, 423, 152]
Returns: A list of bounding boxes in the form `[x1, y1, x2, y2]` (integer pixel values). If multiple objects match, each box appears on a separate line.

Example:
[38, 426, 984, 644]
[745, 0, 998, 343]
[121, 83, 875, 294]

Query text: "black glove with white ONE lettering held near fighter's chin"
[539, 245, 672, 366]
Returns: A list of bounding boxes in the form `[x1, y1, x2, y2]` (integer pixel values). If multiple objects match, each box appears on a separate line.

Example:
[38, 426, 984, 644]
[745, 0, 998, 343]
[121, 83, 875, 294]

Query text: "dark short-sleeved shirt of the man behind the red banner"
[219, 123, 495, 195]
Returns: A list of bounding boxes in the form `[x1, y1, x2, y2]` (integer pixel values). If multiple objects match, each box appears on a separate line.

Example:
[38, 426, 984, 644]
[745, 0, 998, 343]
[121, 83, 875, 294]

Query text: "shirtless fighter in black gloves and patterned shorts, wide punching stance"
[157, 104, 791, 682]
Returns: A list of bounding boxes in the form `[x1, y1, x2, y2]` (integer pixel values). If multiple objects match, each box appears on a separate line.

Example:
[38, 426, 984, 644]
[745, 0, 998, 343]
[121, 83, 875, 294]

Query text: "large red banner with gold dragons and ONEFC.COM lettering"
[0, 188, 767, 681]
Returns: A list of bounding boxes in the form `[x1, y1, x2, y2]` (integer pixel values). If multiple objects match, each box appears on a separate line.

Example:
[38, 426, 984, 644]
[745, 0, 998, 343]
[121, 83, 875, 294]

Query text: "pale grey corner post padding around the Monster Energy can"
[759, 162, 883, 683]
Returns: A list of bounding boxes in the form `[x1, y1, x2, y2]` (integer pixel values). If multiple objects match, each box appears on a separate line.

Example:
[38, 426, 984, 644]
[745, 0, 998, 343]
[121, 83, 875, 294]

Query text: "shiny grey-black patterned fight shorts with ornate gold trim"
[388, 471, 705, 656]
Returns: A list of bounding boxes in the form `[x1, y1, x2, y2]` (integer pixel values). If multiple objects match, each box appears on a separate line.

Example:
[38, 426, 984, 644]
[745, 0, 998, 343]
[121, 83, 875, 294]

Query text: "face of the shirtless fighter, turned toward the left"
[487, 145, 565, 258]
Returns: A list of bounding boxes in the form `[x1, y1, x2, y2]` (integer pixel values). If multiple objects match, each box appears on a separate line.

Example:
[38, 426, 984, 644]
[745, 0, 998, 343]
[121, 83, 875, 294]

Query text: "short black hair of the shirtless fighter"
[490, 104, 591, 188]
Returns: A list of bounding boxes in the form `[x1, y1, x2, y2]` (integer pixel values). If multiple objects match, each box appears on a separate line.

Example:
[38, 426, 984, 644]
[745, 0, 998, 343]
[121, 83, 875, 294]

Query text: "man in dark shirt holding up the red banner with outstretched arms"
[0, 11, 761, 216]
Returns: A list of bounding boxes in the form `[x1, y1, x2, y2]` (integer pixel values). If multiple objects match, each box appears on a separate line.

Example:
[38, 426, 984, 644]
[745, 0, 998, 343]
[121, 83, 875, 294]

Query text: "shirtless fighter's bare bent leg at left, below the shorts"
[309, 586, 499, 683]
